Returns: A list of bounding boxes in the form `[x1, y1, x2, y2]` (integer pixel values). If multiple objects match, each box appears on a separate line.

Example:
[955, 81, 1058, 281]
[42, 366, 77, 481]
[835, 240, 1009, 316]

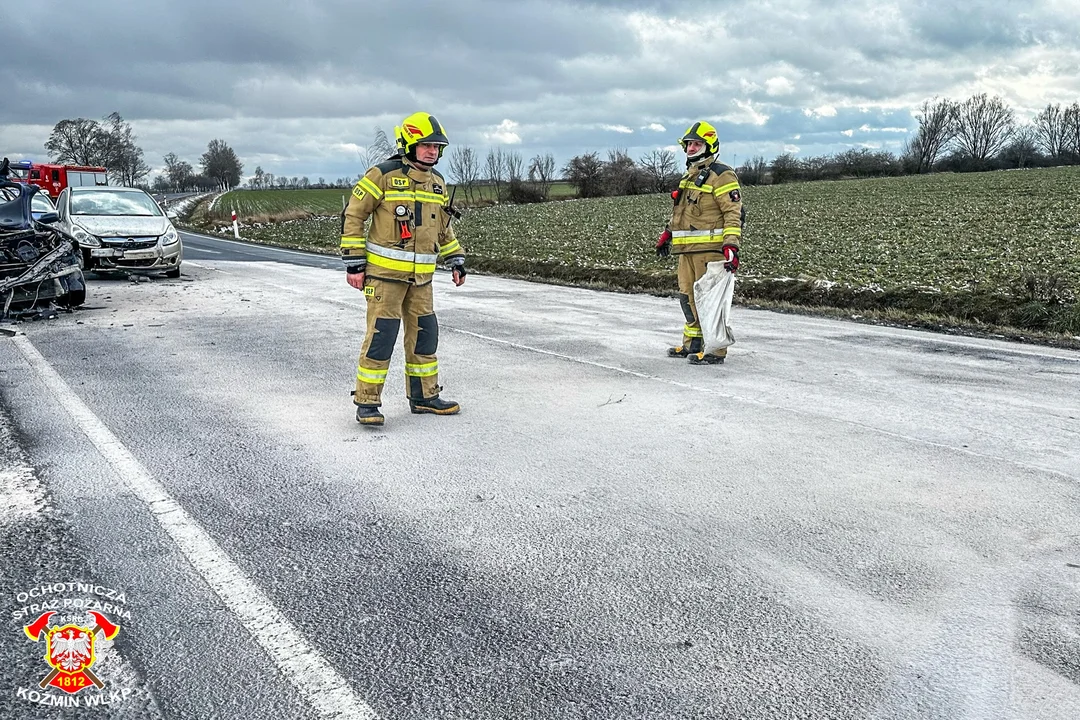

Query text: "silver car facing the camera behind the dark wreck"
[56, 187, 184, 277]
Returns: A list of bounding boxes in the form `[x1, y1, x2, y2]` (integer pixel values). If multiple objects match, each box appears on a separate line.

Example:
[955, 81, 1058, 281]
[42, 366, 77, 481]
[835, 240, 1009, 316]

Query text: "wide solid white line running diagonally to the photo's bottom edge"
[12, 335, 378, 720]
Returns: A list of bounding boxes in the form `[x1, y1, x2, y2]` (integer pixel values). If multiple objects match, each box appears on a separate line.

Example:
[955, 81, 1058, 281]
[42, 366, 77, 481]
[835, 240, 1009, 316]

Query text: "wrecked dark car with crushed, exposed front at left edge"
[0, 158, 86, 317]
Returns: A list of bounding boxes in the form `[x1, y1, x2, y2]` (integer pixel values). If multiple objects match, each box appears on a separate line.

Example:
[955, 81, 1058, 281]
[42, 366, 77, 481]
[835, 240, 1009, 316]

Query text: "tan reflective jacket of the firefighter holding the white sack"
[669, 155, 744, 254]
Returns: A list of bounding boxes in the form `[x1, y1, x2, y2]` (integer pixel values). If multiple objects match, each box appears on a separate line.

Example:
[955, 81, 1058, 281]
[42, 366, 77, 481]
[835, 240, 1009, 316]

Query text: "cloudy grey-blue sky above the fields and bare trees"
[0, 0, 1080, 181]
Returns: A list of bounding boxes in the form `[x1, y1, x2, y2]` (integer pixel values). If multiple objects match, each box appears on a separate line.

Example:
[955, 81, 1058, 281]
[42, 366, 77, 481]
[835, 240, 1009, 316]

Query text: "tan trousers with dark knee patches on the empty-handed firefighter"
[353, 277, 442, 406]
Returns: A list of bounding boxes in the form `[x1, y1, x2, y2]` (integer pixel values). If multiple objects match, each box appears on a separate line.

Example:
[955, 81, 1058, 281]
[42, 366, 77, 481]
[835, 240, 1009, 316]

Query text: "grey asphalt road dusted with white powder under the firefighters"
[0, 234, 1080, 720]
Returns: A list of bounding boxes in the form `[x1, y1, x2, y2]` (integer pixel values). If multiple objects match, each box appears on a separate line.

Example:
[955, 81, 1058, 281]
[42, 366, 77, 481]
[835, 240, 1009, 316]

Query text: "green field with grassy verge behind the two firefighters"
[185, 167, 1080, 340]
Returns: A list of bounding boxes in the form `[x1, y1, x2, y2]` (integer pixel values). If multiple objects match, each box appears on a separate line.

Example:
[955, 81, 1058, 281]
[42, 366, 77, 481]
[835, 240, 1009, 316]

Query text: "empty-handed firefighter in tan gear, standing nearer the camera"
[341, 112, 465, 425]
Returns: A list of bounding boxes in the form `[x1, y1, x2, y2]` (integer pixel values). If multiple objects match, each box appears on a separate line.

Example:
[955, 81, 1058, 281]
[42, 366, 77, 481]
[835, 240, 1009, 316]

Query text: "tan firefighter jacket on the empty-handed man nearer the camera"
[341, 158, 465, 285]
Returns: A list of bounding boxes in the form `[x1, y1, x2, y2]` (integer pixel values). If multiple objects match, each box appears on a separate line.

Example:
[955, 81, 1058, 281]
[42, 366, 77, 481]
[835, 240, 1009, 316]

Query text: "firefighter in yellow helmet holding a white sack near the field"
[656, 121, 743, 365]
